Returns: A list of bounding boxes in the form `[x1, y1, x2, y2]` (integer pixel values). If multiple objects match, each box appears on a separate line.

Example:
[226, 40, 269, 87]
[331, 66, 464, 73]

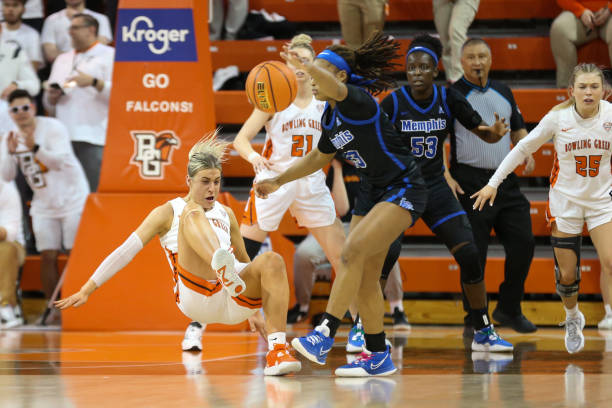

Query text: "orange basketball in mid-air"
[245, 61, 297, 113]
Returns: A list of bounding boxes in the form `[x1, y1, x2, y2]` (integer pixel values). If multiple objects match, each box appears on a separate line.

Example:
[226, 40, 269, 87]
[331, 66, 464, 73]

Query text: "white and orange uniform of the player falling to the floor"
[159, 197, 262, 324]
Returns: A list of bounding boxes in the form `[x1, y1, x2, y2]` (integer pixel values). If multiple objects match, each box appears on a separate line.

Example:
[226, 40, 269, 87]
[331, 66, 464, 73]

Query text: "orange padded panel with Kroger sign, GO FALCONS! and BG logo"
[99, 0, 215, 192]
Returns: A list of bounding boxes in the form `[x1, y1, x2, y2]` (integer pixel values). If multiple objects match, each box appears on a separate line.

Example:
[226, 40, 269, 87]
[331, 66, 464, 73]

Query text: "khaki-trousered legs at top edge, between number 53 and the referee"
[433, 0, 480, 83]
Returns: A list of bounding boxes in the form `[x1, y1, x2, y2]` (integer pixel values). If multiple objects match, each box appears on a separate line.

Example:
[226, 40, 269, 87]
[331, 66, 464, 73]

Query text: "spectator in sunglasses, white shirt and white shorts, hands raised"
[0, 89, 89, 322]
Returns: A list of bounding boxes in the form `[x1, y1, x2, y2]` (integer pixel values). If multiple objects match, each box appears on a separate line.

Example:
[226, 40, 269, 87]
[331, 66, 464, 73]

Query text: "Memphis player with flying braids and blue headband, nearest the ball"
[255, 33, 427, 376]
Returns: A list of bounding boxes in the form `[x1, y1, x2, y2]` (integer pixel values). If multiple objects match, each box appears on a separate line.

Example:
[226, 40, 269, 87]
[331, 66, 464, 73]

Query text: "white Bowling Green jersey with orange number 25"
[521, 101, 612, 207]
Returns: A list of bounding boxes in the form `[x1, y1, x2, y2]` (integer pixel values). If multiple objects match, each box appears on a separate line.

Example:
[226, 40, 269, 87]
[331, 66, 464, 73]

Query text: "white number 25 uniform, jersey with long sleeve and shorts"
[489, 101, 612, 234]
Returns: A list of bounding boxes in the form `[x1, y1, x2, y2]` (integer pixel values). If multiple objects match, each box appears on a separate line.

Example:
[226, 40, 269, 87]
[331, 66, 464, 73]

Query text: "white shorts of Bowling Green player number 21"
[242, 171, 336, 231]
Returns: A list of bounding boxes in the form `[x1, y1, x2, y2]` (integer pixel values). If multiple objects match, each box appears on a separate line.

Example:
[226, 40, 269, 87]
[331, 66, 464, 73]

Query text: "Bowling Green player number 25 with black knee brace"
[472, 64, 612, 353]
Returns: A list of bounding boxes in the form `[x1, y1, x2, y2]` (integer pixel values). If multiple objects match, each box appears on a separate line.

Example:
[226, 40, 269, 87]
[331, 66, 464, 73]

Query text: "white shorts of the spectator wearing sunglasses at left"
[32, 212, 81, 252]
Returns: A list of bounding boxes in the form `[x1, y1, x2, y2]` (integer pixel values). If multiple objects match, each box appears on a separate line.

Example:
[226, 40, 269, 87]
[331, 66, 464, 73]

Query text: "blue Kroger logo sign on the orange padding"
[116, 9, 198, 61]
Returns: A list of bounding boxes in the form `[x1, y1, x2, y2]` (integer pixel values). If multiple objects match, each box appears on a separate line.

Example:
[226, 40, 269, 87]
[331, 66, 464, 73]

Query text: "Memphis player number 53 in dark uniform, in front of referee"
[381, 34, 512, 351]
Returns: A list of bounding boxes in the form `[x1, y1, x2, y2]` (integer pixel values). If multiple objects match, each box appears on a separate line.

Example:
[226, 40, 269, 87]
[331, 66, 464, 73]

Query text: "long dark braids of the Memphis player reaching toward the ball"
[327, 32, 400, 95]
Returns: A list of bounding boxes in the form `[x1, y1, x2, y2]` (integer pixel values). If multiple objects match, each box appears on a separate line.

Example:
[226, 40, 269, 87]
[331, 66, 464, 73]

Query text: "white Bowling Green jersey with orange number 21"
[262, 97, 325, 173]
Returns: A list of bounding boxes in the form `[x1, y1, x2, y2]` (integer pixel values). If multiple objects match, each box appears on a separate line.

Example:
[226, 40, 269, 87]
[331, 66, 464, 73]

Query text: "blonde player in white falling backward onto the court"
[56, 134, 301, 375]
